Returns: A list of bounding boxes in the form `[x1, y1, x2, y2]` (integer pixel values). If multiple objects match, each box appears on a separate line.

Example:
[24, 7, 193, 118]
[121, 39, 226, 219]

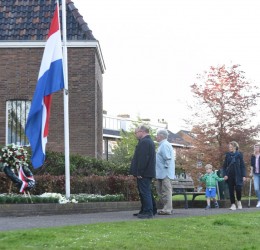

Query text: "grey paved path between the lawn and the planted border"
[0, 207, 260, 231]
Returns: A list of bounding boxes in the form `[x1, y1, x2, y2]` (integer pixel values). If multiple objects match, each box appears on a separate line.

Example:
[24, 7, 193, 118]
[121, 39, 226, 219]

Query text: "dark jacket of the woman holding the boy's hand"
[223, 151, 246, 186]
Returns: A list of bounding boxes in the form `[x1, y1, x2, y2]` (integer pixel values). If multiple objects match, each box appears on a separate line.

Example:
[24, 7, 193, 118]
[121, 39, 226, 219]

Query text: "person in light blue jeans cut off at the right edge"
[250, 144, 260, 208]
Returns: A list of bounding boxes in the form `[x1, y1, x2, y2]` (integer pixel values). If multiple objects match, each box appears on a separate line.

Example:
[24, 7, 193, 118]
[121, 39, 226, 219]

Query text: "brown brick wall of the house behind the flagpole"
[0, 48, 103, 158]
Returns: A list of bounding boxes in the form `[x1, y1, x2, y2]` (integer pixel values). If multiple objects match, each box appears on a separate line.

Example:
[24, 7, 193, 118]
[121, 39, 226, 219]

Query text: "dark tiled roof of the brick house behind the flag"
[0, 0, 96, 41]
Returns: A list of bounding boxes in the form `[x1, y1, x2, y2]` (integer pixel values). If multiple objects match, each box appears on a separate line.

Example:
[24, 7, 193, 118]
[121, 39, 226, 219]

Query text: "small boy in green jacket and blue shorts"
[200, 164, 224, 209]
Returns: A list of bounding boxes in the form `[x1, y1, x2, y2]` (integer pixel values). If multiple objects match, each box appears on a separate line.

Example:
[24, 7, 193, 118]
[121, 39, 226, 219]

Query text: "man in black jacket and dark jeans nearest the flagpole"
[130, 125, 156, 219]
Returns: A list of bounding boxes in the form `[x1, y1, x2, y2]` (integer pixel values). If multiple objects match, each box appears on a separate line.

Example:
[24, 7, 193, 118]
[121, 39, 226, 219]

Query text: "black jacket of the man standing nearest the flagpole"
[130, 135, 156, 178]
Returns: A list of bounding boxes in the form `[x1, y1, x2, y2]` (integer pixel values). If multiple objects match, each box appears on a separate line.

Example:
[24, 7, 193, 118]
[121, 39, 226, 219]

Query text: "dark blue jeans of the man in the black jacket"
[137, 177, 153, 215]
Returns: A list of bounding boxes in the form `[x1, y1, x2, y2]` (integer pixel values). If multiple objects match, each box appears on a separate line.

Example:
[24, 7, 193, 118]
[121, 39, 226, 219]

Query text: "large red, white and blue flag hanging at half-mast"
[25, 3, 64, 168]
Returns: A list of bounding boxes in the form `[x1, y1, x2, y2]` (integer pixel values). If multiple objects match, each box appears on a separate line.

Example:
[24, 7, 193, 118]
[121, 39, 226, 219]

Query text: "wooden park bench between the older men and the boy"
[172, 179, 205, 209]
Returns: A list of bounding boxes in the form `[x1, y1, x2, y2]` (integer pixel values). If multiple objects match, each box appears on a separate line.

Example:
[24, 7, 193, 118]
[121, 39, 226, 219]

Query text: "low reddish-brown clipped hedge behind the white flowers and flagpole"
[0, 173, 139, 201]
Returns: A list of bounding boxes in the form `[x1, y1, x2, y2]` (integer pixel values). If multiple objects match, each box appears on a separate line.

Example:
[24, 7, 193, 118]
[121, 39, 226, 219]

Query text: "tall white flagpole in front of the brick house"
[62, 0, 70, 199]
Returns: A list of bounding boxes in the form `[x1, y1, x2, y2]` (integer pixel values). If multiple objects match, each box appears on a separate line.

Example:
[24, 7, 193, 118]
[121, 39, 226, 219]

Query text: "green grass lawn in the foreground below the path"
[0, 212, 260, 250]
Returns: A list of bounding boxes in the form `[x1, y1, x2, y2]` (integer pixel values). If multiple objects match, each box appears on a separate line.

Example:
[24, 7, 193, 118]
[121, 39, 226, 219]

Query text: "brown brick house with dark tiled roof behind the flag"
[0, 0, 105, 158]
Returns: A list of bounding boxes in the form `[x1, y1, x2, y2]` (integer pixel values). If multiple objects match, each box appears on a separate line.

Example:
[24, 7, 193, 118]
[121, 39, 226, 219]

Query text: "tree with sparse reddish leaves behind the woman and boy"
[186, 65, 260, 182]
